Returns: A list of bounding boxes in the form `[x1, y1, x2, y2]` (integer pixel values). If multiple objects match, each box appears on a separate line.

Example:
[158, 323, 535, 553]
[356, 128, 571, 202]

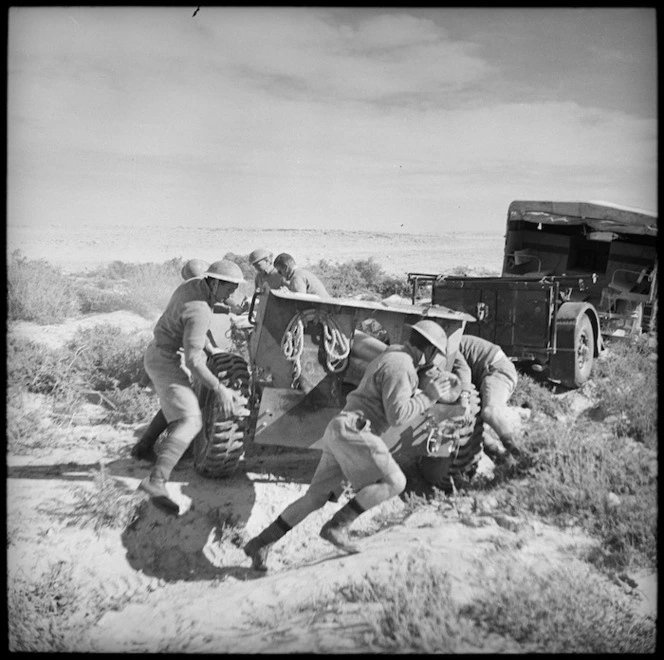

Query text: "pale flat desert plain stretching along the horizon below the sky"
[7, 225, 504, 275]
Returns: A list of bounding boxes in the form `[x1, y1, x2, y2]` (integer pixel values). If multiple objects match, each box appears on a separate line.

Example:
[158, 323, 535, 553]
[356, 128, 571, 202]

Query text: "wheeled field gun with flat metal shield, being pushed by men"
[193, 290, 483, 487]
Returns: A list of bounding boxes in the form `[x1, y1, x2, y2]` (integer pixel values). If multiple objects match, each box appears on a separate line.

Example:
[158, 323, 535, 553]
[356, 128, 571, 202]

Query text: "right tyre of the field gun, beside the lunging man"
[418, 386, 484, 493]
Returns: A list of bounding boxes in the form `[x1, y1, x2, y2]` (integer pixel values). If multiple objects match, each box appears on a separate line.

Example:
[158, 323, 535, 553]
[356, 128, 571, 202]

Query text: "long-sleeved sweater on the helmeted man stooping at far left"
[154, 277, 219, 389]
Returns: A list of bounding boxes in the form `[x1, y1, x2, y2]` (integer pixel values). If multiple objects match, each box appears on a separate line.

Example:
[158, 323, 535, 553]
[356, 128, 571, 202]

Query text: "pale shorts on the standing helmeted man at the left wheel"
[143, 342, 201, 424]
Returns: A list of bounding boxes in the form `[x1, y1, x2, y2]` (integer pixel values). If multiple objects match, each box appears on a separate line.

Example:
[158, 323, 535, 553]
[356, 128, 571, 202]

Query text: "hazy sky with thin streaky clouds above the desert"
[7, 6, 657, 234]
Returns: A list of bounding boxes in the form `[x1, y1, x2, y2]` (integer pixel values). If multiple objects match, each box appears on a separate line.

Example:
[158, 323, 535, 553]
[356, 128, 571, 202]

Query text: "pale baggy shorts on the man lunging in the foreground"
[309, 411, 401, 501]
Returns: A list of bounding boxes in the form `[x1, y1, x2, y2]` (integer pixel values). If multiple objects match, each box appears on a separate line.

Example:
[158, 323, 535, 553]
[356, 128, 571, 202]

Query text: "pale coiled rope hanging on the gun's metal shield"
[281, 309, 350, 388]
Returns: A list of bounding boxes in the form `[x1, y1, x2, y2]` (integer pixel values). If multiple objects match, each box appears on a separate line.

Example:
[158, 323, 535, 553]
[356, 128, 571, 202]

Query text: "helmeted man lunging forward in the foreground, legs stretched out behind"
[244, 320, 456, 571]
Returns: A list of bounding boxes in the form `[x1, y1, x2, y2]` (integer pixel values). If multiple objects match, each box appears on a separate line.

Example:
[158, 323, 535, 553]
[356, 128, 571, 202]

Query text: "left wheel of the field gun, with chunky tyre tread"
[193, 353, 250, 479]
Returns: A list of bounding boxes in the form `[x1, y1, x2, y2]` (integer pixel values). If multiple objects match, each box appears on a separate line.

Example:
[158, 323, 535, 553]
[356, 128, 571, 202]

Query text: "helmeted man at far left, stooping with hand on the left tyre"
[139, 260, 249, 515]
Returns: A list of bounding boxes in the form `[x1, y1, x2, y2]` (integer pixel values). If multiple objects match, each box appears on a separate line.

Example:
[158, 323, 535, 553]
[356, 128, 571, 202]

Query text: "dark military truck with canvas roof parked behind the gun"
[408, 200, 657, 388]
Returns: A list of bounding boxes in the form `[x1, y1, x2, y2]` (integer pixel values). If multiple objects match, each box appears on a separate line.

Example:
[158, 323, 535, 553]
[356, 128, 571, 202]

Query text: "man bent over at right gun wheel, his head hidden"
[452, 335, 520, 461]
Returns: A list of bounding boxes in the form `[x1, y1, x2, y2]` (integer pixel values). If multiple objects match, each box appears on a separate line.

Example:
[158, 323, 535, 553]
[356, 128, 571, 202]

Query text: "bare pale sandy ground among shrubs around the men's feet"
[7, 231, 657, 653]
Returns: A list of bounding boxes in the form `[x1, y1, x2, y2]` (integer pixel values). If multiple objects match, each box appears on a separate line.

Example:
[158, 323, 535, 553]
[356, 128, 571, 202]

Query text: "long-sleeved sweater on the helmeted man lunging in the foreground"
[344, 344, 434, 435]
